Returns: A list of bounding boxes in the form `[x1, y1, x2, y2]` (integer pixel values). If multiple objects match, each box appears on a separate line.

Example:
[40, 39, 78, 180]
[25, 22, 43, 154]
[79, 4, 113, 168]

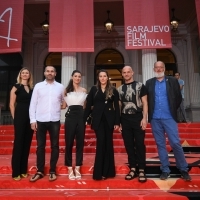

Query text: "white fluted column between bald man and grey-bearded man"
[142, 49, 157, 84]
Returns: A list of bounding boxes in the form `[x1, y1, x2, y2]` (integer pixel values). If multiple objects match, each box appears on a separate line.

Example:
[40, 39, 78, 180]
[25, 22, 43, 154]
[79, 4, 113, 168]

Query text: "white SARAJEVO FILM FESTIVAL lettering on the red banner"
[127, 25, 170, 47]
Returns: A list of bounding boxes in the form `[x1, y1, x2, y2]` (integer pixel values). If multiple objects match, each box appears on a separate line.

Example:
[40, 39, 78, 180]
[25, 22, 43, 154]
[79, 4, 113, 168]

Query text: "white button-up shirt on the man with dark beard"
[29, 80, 64, 123]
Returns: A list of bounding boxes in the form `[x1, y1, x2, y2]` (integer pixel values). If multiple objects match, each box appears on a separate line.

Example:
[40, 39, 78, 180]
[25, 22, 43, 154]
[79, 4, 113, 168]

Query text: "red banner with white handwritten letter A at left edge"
[0, 0, 24, 53]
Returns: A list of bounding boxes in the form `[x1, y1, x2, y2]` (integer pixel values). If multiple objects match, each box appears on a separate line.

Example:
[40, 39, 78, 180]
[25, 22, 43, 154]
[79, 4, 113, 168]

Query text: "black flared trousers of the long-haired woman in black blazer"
[93, 115, 116, 180]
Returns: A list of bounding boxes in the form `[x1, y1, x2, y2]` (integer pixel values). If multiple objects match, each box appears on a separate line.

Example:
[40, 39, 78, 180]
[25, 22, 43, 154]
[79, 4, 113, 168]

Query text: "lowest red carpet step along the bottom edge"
[1, 188, 191, 200]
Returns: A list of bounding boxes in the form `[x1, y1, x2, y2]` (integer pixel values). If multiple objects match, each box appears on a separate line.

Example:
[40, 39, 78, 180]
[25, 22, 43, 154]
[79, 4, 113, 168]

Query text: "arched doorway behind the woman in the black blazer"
[94, 49, 124, 87]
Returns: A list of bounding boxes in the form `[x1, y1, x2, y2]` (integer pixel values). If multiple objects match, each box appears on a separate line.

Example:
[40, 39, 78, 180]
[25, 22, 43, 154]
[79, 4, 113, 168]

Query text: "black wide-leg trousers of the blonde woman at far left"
[11, 115, 33, 177]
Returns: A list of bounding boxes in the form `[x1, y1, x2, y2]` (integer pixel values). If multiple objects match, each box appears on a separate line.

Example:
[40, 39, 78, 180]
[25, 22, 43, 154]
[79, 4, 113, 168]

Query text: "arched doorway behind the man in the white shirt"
[44, 52, 62, 83]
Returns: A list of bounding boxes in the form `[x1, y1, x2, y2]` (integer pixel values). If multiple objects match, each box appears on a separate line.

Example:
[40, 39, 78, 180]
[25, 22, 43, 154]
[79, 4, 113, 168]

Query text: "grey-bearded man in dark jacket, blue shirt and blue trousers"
[146, 61, 191, 181]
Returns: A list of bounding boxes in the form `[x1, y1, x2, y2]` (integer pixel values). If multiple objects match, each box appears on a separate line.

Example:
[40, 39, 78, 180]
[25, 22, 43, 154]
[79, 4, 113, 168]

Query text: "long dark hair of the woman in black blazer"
[96, 69, 113, 99]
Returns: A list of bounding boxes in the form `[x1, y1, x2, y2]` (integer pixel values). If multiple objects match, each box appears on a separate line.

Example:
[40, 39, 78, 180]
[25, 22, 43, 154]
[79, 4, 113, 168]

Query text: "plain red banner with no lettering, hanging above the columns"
[49, 0, 94, 52]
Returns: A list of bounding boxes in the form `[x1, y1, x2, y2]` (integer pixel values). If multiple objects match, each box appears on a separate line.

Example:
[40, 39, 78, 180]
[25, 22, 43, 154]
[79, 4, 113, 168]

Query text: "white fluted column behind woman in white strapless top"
[61, 52, 77, 123]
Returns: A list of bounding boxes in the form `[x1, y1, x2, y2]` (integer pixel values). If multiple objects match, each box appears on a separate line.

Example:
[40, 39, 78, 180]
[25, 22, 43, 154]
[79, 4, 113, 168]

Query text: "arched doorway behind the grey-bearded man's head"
[157, 49, 177, 76]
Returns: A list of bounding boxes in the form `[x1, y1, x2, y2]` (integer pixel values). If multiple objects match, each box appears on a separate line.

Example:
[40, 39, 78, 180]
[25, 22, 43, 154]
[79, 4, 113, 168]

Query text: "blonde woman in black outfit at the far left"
[10, 68, 33, 181]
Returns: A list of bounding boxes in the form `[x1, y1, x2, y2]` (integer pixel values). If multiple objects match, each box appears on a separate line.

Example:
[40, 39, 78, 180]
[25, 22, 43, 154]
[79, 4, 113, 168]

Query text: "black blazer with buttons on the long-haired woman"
[84, 86, 120, 130]
